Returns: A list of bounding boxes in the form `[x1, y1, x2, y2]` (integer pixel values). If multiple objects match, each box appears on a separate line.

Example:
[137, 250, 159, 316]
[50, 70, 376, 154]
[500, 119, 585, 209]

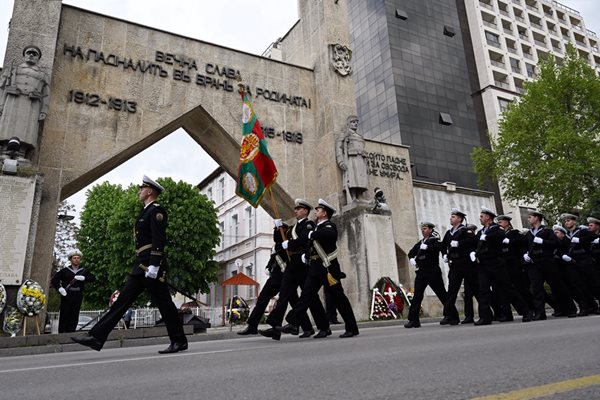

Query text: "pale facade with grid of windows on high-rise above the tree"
[464, 0, 600, 225]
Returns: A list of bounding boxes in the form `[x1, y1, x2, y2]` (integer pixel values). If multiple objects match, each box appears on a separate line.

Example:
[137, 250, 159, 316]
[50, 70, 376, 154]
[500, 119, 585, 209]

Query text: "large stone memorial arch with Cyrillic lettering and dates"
[0, 0, 416, 318]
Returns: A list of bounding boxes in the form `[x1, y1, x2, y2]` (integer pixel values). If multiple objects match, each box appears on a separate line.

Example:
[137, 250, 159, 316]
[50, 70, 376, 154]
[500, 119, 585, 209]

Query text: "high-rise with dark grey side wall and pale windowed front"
[348, 0, 600, 225]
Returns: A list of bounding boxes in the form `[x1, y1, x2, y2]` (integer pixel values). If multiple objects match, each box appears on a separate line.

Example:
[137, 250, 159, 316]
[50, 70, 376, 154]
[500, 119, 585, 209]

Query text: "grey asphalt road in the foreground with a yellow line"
[0, 316, 600, 400]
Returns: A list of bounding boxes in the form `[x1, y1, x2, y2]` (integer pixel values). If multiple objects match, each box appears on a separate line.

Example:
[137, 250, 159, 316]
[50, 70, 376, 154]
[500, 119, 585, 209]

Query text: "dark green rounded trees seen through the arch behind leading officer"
[79, 178, 220, 307]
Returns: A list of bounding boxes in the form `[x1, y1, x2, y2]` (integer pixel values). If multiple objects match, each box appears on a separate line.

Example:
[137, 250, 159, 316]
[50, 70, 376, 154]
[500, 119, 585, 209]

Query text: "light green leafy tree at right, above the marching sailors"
[472, 46, 600, 216]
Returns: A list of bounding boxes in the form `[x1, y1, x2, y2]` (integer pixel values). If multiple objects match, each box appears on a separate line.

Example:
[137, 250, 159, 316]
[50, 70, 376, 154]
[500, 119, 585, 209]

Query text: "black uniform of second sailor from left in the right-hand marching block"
[442, 224, 477, 323]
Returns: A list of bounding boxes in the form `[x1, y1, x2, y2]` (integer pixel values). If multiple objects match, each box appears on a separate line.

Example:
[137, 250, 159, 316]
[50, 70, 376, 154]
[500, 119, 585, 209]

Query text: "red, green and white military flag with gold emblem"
[235, 92, 277, 208]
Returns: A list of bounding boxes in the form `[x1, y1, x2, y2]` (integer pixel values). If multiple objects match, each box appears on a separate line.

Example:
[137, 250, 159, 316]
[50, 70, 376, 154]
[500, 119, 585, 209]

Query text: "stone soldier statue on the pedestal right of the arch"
[335, 115, 368, 204]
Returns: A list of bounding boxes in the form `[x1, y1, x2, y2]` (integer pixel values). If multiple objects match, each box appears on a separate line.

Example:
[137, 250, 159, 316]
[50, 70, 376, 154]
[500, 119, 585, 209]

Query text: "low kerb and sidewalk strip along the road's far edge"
[0, 318, 432, 358]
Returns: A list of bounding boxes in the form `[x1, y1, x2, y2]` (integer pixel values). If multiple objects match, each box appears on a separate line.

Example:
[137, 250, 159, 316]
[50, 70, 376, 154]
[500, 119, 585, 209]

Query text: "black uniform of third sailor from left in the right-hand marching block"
[475, 224, 532, 325]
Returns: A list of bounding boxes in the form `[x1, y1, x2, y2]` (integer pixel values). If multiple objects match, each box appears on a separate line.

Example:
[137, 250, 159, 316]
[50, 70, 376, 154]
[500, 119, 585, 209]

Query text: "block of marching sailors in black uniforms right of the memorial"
[404, 207, 600, 328]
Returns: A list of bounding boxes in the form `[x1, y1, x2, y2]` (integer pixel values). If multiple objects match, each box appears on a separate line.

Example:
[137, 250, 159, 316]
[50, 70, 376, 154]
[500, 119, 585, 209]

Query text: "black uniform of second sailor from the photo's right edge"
[567, 227, 600, 314]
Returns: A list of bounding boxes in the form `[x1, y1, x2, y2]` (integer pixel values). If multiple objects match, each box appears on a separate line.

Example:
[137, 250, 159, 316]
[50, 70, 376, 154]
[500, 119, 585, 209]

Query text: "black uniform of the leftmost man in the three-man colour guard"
[247, 229, 298, 333]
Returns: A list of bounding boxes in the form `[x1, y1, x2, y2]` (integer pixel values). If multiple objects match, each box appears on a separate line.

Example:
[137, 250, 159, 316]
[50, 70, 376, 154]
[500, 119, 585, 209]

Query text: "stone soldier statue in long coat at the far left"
[0, 46, 48, 158]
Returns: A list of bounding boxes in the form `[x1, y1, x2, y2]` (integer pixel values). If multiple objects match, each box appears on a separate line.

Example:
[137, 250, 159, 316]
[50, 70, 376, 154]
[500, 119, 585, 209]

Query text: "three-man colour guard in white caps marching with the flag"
[238, 199, 359, 340]
